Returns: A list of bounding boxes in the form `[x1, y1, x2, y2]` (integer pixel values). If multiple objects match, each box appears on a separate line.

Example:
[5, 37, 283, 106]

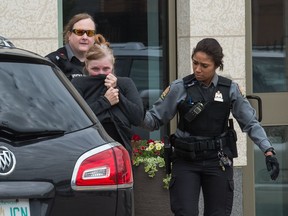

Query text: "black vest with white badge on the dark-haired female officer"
[178, 74, 232, 137]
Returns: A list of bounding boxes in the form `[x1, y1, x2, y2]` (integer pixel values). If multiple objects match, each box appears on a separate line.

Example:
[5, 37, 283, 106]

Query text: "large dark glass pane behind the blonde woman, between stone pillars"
[62, 0, 169, 139]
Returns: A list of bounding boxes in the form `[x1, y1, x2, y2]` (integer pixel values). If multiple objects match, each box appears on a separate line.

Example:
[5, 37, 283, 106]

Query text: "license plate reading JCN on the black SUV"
[0, 199, 31, 216]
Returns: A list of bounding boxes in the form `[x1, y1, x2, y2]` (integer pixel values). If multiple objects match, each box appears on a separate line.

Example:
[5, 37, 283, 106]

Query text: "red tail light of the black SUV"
[71, 143, 133, 190]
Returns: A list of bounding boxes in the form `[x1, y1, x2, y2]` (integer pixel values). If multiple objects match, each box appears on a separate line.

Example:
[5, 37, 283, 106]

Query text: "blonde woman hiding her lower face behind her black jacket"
[72, 34, 144, 155]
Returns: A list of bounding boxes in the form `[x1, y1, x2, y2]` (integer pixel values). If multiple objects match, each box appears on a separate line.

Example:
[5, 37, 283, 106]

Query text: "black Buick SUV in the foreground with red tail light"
[0, 37, 134, 216]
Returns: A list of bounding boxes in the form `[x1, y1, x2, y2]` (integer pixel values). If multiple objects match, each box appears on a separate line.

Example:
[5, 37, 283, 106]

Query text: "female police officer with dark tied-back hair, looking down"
[142, 38, 279, 216]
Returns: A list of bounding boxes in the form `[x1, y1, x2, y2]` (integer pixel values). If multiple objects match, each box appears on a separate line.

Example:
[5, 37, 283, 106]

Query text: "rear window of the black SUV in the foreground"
[0, 62, 92, 132]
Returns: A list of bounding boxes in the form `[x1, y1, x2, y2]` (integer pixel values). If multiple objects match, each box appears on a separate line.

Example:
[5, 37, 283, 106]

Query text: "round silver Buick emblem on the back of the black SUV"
[0, 146, 16, 176]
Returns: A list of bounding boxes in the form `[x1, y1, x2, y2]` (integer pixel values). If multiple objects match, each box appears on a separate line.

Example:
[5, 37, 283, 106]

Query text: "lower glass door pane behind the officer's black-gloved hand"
[254, 126, 288, 216]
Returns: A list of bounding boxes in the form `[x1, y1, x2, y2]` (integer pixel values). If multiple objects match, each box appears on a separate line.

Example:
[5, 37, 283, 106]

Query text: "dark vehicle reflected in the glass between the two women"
[111, 42, 168, 139]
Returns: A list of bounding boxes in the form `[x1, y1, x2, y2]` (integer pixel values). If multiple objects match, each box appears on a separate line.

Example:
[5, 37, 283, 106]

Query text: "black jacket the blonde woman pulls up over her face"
[71, 75, 144, 153]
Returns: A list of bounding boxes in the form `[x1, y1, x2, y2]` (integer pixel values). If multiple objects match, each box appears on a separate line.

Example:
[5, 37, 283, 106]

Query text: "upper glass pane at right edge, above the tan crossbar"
[252, 0, 288, 93]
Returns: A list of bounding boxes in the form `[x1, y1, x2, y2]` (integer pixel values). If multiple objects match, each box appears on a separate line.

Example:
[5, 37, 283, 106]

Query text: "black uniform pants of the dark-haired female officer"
[169, 153, 234, 216]
